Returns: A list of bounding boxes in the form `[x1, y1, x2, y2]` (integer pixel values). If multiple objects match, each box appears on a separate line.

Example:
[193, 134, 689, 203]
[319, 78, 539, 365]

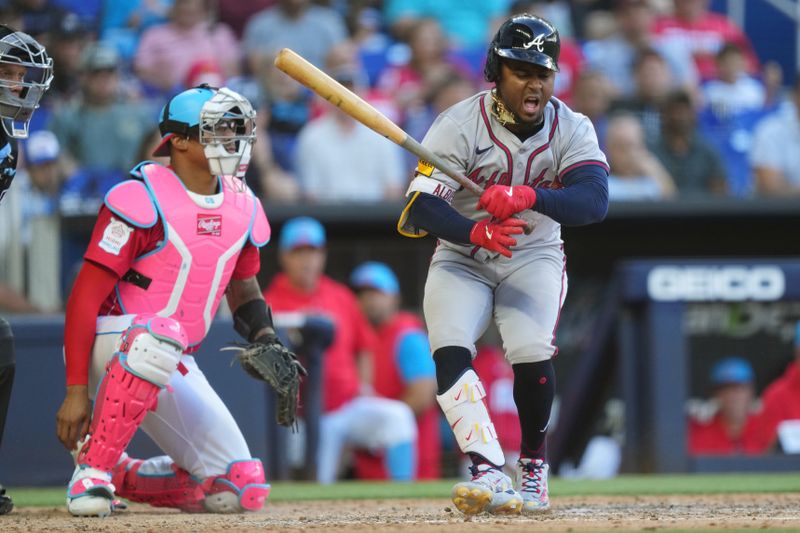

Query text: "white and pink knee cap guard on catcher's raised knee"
[117, 315, 188, 387]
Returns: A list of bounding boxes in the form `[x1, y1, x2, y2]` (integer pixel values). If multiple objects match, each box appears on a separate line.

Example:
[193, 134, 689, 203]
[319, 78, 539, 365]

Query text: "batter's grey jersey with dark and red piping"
[398, 91, 608, 259]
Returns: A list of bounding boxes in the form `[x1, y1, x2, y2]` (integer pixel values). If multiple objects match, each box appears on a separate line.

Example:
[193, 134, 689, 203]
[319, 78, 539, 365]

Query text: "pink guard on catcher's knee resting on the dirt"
[204, 459, 270, 513]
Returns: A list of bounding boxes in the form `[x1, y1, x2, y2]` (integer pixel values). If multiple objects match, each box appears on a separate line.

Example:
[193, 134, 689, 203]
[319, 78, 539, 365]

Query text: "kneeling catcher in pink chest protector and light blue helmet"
[57, 85, 304, 516]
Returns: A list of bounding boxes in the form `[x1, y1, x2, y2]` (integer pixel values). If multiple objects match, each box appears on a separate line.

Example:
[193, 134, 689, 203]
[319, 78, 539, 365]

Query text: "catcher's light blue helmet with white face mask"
[153, 84, 256, 178]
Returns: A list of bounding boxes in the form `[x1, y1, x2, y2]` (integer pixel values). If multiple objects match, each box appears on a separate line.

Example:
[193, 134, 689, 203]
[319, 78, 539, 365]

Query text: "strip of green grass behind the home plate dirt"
[9, 472, 800, 507]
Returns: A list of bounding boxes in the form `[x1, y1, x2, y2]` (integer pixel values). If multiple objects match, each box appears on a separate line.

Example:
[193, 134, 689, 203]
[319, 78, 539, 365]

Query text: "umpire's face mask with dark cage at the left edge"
[0, 26, 53, 139]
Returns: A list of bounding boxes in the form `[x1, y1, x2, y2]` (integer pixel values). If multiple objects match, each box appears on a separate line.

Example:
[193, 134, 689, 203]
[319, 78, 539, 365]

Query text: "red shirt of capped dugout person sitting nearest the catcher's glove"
[264, 273, 374, 413]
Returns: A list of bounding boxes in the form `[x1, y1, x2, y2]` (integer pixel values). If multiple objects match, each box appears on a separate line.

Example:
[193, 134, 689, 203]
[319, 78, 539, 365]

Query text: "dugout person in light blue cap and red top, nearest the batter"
[350, 261, 441, 479]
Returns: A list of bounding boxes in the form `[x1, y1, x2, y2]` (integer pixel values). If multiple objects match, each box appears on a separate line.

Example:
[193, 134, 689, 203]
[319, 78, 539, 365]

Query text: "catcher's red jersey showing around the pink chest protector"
[83, 205, 261, 316]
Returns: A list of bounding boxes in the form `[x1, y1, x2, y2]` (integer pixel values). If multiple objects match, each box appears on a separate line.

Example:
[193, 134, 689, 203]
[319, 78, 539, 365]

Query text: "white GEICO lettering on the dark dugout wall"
[647, 265, 786, 302]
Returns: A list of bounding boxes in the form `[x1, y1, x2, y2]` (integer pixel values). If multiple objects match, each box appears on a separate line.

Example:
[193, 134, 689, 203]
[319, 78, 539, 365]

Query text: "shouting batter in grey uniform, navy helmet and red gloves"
[398, 14, 608, 514]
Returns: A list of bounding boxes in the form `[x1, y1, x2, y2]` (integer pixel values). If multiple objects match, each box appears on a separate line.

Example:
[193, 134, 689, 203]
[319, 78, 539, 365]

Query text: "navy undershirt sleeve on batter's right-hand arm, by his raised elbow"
[533, 164, 608, 226]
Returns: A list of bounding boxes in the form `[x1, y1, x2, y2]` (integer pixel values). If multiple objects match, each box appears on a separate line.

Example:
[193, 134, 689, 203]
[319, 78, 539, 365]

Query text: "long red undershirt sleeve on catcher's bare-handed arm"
[64, 261, 119, 386]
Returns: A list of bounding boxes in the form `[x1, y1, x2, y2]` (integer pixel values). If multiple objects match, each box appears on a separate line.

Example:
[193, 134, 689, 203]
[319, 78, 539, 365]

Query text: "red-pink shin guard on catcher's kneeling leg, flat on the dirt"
[111, 458, 206, 513]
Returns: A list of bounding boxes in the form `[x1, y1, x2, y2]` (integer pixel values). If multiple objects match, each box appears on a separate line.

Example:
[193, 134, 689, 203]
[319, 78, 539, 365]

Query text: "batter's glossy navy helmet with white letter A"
[483, 13, 561, 81]
